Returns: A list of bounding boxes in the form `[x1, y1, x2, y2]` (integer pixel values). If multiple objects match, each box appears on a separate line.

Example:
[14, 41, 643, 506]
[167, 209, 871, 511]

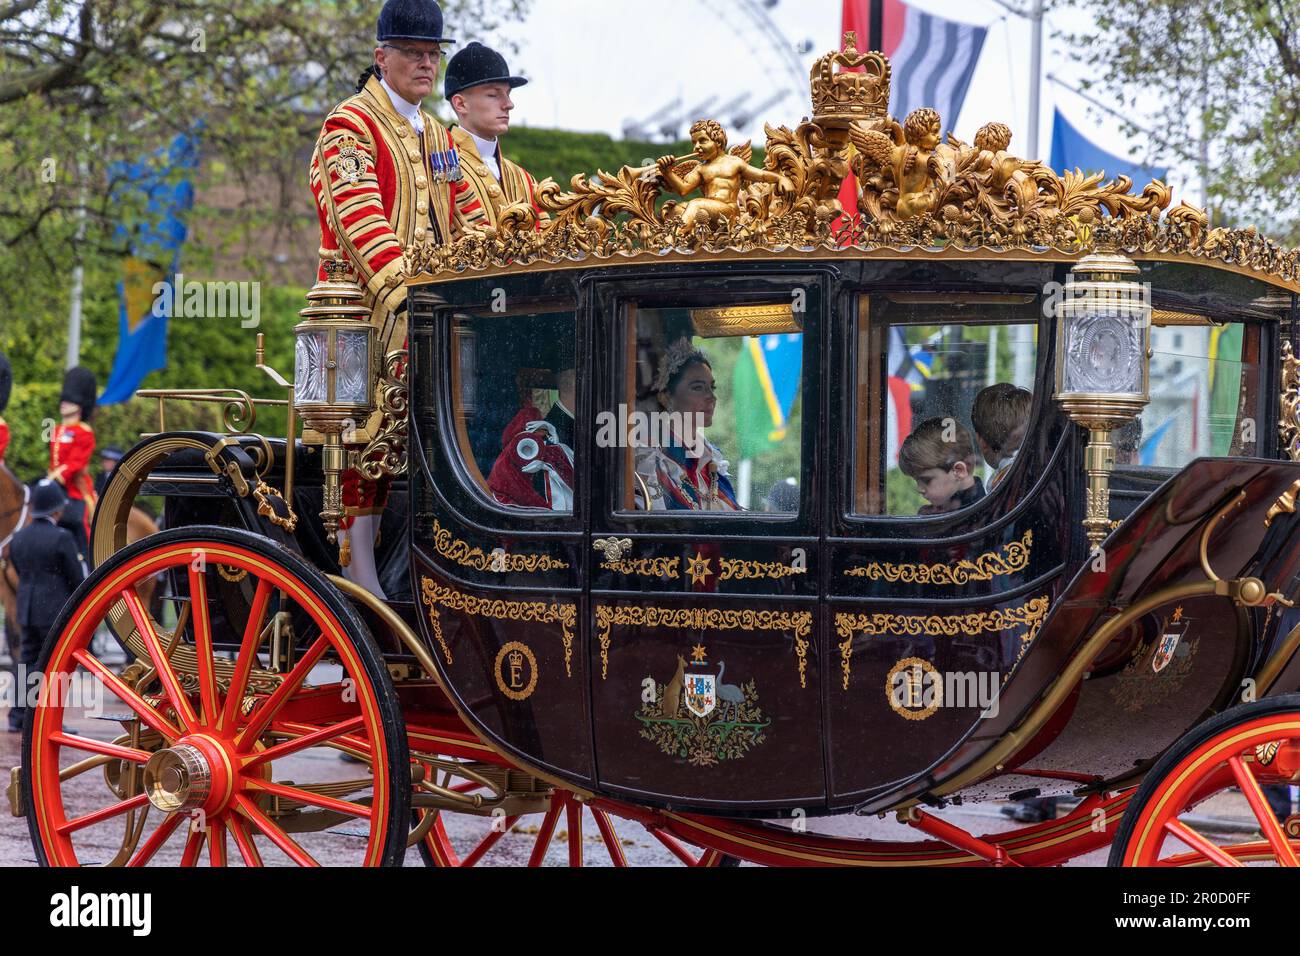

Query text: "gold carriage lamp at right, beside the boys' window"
[1056, 252, 1152, 549]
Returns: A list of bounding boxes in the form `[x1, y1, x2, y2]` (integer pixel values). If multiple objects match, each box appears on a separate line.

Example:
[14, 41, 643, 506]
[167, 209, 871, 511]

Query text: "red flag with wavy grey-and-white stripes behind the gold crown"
[840, 0, 988, 222]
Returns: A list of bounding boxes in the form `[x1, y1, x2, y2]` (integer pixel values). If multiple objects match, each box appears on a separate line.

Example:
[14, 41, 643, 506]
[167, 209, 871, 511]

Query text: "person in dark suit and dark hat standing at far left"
[9, 479, 86, 734]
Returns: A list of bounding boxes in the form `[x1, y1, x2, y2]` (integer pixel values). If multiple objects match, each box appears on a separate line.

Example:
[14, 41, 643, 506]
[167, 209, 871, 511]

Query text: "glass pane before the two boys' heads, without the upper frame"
[857, 316, 1037, 516]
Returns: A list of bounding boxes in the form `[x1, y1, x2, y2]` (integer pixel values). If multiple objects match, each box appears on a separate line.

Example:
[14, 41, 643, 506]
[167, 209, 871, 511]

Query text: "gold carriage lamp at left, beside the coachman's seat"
[294, 261, 380, 544]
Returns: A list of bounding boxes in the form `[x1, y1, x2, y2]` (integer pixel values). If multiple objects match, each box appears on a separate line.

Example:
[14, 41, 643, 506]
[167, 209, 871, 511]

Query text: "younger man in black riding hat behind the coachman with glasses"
[443, 43, 537, 232]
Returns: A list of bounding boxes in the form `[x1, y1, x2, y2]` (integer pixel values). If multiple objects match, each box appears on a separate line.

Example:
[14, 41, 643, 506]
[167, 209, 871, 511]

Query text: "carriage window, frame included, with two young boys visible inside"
[854, 294, 1039, 518]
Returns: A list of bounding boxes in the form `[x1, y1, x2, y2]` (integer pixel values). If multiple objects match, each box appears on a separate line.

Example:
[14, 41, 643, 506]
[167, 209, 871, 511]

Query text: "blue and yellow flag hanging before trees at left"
[99, 133, 198, 405]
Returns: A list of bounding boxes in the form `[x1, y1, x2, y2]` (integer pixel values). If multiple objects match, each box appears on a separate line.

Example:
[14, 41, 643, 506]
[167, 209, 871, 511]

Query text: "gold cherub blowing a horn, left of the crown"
[655, 120, 794, 230]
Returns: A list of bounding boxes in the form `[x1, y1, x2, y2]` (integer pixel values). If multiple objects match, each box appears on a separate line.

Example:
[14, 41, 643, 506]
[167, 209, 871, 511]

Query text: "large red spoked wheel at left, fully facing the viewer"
[22, 528, 411, 866]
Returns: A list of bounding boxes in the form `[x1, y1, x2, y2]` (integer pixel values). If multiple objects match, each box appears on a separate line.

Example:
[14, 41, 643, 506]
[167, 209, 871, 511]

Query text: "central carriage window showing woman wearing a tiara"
[618, 302, 803, 515]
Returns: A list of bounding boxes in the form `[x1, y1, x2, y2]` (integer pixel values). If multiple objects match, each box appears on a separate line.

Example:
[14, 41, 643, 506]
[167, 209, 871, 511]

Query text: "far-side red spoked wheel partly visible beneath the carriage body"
[413, 757, 737, 866]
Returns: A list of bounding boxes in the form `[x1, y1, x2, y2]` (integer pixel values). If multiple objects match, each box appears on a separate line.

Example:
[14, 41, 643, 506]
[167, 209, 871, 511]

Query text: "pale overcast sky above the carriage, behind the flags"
[483, 0, 1199, 202]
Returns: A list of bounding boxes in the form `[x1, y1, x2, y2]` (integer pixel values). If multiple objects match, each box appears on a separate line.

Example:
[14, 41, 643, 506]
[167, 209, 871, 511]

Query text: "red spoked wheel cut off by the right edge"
[1110, 695, 1300, 866]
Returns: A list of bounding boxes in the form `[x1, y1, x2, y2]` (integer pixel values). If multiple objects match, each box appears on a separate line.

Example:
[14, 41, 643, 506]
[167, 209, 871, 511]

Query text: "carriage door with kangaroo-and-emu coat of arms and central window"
[589, 272, 826, 809]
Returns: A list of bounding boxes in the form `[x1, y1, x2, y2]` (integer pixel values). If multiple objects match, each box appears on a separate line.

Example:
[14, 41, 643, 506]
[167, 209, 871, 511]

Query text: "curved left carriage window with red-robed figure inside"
[451, 307, 577, 512]
